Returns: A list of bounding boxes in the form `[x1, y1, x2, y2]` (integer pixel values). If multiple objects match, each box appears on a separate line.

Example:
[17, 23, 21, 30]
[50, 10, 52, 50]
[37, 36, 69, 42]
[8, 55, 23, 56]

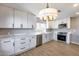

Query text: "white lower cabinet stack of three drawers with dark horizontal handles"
[14, 36, 29, 54]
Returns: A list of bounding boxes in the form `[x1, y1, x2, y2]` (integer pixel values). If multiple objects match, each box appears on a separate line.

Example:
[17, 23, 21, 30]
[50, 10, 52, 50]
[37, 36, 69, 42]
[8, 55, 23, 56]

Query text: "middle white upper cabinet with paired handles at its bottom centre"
[14, 10, 27, 28]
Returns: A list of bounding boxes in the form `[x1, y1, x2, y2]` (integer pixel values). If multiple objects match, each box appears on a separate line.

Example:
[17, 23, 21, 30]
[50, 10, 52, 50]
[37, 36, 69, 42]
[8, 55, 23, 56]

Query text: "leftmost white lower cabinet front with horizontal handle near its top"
[1, 38, 14, 56]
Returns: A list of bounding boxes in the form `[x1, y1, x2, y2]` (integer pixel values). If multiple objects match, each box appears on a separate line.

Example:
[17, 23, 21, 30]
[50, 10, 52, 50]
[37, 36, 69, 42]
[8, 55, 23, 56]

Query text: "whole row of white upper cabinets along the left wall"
[0, 5, 36, 28]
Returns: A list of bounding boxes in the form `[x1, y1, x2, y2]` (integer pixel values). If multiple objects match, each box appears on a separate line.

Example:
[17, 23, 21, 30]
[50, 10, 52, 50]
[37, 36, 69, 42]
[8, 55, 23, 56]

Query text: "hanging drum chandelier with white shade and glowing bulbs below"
[38, 3, 59, 21]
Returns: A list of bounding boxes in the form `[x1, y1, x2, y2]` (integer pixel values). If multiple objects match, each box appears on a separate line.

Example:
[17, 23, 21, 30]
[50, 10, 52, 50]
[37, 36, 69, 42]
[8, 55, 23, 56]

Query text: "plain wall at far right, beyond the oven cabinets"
[71, 17, 79, 44]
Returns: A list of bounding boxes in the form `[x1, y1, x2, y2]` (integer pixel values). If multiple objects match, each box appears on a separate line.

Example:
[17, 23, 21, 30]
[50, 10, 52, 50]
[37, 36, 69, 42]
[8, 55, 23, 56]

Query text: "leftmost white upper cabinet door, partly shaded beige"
[0, 6, 13, 28]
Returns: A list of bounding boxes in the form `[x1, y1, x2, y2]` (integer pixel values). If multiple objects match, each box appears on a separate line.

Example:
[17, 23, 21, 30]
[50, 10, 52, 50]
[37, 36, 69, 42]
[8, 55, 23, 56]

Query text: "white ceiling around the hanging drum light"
[0, 3, 79, 19]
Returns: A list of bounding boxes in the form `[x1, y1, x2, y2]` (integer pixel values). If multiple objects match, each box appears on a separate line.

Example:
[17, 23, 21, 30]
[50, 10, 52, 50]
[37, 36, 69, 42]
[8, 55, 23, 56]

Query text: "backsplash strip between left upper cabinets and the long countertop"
[0, 29, 34, 35]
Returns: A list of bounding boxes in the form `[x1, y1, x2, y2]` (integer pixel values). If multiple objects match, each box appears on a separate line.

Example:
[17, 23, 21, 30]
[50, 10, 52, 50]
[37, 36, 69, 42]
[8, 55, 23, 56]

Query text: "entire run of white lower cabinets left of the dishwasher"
[0, 36, 36, 56]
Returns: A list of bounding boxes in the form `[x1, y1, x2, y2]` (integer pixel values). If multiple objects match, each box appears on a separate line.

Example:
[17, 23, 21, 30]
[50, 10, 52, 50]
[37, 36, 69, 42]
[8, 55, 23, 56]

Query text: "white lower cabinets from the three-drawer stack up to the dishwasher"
[15, 36, 36, 54]
